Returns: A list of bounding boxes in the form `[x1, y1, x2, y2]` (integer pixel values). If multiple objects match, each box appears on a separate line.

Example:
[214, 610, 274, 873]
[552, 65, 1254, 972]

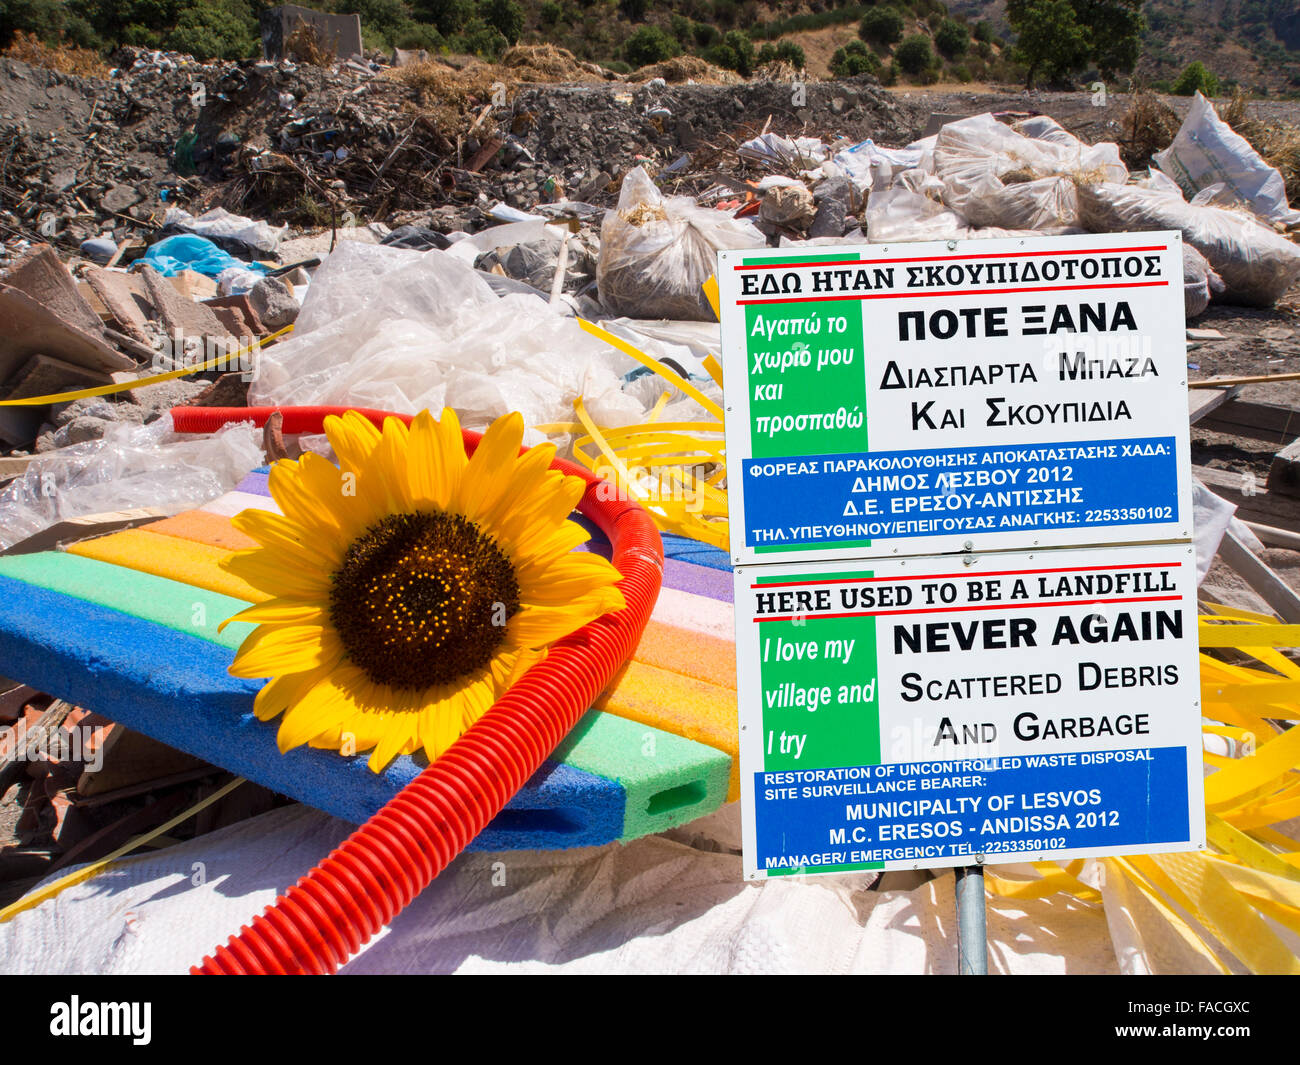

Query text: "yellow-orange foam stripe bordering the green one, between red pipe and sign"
[595, 662, 740, 802]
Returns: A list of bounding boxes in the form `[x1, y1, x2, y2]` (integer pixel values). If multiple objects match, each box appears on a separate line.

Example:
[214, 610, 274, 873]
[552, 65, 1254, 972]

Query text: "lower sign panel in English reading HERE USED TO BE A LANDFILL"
[736, 544, 1205, 878]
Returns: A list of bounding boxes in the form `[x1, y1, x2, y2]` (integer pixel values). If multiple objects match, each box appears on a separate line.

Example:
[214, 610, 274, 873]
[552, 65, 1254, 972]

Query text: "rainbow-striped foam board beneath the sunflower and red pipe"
[0, 469, 736, 850]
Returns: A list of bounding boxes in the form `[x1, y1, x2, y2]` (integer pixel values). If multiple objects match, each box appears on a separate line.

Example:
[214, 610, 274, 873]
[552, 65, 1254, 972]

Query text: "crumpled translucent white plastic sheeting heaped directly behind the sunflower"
[250, 241, 646, 442]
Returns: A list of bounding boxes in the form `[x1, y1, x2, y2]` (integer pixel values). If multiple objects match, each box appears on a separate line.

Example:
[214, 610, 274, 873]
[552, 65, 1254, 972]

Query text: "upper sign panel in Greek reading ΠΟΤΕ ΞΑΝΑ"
[718, 233, 1191, 564]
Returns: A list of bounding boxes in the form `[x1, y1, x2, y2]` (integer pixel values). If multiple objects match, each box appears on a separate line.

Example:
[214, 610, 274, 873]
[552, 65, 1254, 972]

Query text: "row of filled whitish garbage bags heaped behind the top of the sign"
[719, 95, 1300, 319]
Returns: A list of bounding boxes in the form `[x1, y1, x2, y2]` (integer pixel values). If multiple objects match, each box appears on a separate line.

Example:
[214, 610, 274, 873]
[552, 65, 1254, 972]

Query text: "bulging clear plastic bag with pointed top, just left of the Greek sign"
[595, 166, 766, 321]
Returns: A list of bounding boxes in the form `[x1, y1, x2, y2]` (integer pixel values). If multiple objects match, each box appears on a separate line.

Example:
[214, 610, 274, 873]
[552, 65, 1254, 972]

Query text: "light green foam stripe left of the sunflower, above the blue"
[0, 551, 254, 651]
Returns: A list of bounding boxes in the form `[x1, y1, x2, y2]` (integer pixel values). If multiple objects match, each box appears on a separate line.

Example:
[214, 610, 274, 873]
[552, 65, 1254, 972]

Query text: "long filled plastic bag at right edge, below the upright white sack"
[1079, 185, 1300, 307]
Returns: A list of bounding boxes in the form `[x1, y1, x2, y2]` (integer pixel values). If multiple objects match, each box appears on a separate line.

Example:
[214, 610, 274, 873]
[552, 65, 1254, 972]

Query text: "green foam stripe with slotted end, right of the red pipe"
[555, 710, 731, 841]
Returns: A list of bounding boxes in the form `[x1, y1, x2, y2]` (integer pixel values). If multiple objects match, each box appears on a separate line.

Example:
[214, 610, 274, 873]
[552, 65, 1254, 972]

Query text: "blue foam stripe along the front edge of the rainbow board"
[0, 577, 627, 849]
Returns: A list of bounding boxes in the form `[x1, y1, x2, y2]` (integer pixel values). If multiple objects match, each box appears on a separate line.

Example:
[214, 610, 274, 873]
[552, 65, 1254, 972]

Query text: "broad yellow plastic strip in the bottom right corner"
[1149, 854, 1300, 975]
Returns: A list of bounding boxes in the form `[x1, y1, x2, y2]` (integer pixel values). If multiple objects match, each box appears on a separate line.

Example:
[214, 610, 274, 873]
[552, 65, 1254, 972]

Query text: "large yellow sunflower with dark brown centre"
[222, 410, 624, 772]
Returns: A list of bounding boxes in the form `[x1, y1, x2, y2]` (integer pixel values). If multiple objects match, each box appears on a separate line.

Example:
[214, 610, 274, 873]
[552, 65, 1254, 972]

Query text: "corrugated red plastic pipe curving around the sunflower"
[172, 407, 663, 975]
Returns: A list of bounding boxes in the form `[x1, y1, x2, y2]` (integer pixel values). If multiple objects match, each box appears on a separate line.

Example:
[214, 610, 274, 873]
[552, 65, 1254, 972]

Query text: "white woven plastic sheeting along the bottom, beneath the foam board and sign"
[0, 805, 1118, 974]
